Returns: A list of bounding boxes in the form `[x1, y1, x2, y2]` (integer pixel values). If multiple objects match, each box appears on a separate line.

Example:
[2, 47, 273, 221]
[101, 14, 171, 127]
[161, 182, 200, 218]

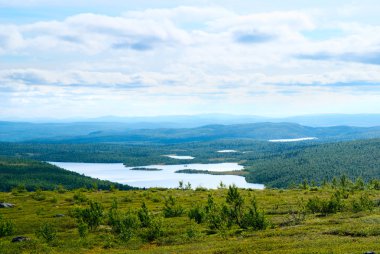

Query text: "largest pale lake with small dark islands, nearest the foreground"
[50, 162, 264, 189]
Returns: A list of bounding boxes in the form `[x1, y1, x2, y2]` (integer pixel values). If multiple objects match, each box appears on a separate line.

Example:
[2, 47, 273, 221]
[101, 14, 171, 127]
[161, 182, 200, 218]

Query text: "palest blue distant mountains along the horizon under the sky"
[2, 114, 380, 129]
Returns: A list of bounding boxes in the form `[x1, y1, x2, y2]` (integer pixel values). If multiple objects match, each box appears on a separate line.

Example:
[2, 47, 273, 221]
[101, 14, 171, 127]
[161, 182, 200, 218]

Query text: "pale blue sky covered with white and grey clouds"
[0, 0, 380, 119]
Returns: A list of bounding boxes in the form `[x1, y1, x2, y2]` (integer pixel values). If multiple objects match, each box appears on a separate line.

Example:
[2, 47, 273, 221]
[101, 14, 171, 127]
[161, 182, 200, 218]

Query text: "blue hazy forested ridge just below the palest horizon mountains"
[0, 122, 380, 143]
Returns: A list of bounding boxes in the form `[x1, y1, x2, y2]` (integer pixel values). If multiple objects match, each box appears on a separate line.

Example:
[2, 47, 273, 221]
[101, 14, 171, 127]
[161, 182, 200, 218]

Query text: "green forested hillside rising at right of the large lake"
[247, 139, 380, 187]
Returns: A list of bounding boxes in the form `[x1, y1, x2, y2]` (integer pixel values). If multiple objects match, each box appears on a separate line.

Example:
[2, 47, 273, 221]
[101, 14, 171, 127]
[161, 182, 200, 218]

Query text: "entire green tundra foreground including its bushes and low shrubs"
[0, 180, 380, 254]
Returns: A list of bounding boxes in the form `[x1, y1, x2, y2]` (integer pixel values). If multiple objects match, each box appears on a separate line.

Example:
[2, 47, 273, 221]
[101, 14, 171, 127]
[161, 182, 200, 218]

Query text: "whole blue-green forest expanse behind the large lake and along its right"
[0, 139, 380, 188]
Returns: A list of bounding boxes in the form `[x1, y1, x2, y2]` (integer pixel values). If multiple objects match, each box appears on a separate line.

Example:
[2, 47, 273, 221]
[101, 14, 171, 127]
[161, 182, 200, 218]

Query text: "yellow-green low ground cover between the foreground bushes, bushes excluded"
[0, 189, 380, 254]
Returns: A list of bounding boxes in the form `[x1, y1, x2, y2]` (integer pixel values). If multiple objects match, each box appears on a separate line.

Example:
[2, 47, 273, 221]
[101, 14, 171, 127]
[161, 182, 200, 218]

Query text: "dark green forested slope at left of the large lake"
[0, 157, 131, 191]
